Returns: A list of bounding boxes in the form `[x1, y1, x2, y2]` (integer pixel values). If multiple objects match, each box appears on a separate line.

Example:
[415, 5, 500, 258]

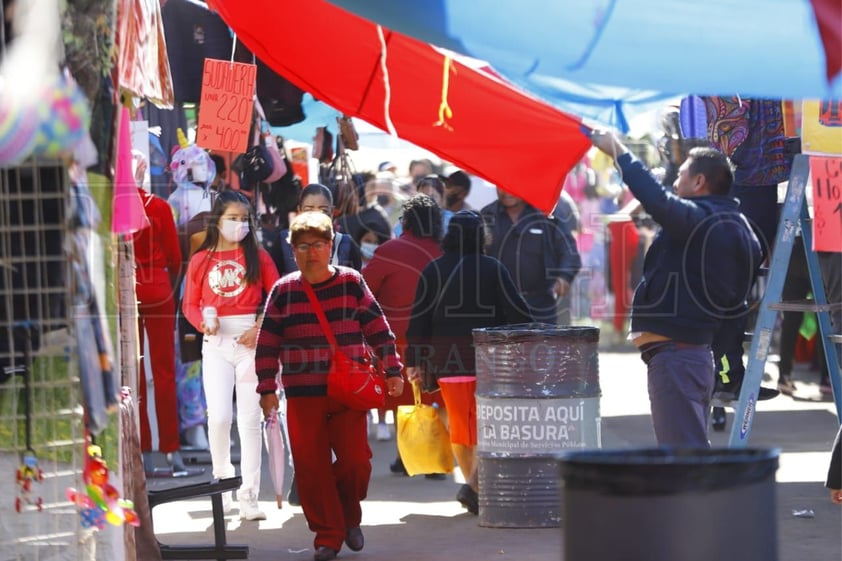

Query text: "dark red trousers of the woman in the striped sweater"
[287, 396, 371, 551]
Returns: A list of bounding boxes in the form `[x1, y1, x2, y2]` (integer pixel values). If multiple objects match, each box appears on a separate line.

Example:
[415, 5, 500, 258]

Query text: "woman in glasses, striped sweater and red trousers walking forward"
[256, 212, 403, 561]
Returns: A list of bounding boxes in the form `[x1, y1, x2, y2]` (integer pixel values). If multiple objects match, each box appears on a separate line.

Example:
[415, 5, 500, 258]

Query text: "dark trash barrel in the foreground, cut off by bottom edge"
[559, 448, 779, 561]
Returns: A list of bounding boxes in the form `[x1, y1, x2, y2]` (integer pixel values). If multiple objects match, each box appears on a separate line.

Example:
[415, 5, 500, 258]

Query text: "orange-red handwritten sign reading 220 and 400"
[196, 58, 257, 152]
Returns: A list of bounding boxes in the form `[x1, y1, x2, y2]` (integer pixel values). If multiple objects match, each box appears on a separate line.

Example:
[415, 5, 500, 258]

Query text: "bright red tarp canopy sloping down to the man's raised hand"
[209, 0, 591, 212]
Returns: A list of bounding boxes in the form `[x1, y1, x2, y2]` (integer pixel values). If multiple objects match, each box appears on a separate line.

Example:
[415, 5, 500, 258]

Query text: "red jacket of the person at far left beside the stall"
[133, 188, 181, 283]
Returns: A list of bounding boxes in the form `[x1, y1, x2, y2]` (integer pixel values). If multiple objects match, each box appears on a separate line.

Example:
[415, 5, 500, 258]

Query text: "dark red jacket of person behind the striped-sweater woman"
[362, 232, 441, 341]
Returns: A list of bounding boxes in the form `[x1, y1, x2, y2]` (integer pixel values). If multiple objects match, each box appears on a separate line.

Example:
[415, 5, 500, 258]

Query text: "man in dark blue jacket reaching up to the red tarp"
[591, 131, 761, 448]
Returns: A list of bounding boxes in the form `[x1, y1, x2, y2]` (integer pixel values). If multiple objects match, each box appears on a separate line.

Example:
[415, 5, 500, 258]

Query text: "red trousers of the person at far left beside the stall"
[135, 270, 181, 452]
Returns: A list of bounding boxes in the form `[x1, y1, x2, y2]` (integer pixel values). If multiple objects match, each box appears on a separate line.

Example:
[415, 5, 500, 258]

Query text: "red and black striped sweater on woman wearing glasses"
[255, 266, 402, 397]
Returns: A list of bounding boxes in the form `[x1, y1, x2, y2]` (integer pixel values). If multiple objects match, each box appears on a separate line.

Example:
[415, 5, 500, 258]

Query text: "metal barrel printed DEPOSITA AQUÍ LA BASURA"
[473, 324, 601, 528]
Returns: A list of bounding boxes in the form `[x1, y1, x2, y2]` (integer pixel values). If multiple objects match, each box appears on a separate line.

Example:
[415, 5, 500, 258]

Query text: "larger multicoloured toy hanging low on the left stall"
[65, 444, 140, 530]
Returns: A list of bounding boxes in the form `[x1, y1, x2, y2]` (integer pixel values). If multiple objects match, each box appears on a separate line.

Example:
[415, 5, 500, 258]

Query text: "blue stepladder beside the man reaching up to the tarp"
[728, 154, 842, 448]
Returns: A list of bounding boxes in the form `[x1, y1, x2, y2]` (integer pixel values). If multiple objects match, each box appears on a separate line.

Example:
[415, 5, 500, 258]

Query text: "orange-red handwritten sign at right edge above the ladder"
[810, 156, 842, 252]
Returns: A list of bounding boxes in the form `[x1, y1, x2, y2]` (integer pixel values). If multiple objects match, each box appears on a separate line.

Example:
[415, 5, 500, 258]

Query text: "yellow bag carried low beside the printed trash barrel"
[397, 383, 453, 475]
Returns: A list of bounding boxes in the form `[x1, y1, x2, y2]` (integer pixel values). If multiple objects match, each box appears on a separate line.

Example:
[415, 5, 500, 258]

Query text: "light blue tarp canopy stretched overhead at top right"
[331, 0, 842, 130]
